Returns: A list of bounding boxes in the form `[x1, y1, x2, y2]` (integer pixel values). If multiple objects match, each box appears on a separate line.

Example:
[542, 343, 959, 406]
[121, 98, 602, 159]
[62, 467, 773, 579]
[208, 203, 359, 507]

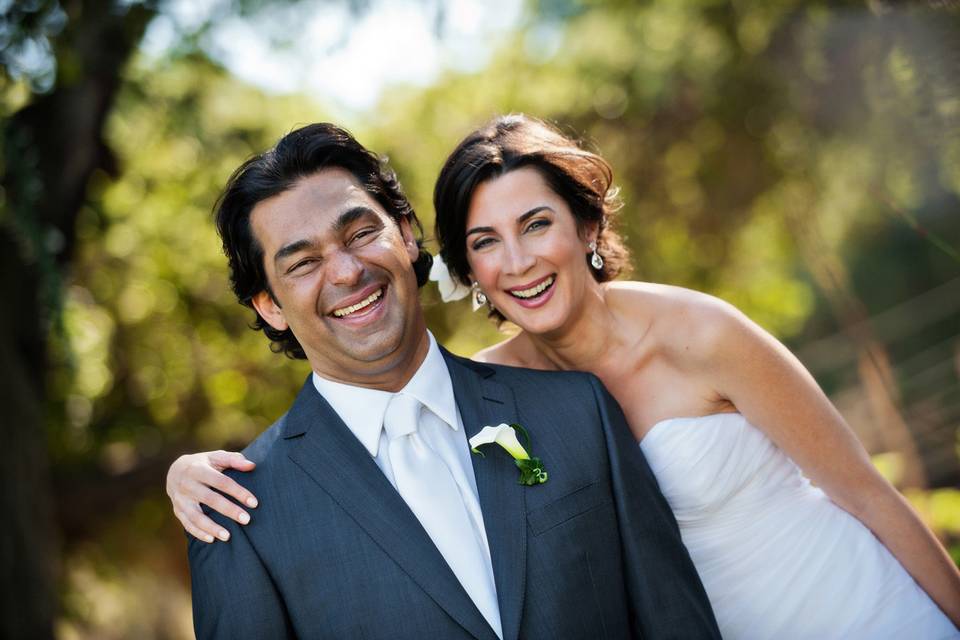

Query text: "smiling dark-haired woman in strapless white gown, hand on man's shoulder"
[168, 116, 960, 638]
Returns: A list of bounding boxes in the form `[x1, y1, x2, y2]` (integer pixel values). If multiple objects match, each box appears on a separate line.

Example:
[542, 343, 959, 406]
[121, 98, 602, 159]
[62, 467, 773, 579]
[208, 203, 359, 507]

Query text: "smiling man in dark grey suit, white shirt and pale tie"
[189, 124, 719, 640]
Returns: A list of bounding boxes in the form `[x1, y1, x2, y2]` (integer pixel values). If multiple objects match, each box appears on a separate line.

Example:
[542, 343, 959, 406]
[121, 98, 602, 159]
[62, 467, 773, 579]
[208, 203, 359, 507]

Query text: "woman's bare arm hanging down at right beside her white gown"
[699, 301, 960, 627]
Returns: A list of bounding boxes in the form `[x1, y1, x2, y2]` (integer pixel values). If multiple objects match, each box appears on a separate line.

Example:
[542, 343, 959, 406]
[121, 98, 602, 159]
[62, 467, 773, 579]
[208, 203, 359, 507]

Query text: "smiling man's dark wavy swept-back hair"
[214, 123, 433, 359]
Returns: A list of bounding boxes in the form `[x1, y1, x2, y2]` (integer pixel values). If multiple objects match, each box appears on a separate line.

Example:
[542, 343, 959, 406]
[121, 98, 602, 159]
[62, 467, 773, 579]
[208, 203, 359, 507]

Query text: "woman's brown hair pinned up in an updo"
[433, 114, 630, 324]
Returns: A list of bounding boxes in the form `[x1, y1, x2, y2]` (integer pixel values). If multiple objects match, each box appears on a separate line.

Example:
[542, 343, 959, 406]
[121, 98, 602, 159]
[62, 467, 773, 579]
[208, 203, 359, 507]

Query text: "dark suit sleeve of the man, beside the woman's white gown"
[589, 375, 720, 638]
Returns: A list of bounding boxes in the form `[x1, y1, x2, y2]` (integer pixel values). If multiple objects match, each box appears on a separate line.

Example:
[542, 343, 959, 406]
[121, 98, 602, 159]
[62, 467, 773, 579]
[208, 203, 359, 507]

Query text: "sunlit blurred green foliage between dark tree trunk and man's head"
[53, 59, 330, 466]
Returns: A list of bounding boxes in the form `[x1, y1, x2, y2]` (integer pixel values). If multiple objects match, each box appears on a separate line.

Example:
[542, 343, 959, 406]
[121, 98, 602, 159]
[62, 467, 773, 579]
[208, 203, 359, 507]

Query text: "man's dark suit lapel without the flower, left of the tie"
[284, 378, 496, 640]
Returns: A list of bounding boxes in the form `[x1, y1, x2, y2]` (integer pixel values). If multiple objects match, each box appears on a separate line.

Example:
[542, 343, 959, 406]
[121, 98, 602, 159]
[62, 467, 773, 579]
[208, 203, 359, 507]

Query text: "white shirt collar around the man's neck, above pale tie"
[313, 331, 459, 457]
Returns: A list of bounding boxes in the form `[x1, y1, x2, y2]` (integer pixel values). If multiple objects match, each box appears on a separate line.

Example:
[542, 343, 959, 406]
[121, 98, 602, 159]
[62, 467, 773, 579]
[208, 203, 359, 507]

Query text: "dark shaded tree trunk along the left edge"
[0, 0, 155, 638]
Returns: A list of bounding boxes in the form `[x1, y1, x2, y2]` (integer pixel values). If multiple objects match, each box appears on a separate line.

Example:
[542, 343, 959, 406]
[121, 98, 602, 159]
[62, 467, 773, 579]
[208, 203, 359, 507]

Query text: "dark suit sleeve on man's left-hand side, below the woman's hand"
[187, 513, 295, 640]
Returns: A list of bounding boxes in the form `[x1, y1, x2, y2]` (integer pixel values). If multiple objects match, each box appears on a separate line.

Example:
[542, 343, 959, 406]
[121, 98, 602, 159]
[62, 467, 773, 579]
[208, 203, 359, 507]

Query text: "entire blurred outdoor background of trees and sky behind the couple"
[0, 0, 960, 640]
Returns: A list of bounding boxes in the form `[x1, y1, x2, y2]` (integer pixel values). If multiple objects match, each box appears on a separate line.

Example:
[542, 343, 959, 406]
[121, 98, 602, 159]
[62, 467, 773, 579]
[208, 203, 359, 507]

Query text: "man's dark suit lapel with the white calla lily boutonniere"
[443, 349, 527, 640]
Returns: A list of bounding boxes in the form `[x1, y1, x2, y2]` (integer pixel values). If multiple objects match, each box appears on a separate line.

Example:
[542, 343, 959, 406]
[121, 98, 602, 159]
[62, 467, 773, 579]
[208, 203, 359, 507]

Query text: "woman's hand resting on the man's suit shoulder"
[167, 451, 257, 542]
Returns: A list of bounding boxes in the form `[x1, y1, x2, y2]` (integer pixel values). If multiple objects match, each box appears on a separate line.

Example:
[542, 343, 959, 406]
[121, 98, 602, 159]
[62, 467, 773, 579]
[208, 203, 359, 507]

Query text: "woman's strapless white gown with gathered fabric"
[640, 413, 960, 640]
